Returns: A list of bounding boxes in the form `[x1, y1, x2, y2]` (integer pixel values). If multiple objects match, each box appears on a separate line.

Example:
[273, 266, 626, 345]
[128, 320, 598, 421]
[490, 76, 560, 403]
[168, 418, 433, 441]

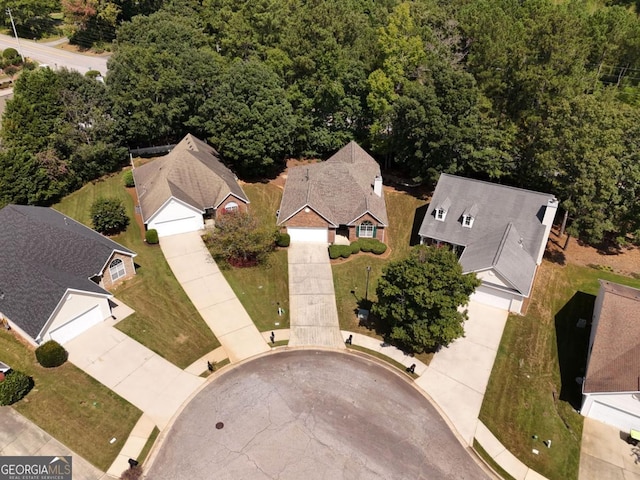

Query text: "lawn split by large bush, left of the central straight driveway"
[222, 183, 289, 331]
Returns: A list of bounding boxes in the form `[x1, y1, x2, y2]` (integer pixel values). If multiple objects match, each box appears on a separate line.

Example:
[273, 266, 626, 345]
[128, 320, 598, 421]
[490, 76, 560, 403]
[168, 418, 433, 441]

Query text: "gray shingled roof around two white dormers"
[419, 173, 555, 296]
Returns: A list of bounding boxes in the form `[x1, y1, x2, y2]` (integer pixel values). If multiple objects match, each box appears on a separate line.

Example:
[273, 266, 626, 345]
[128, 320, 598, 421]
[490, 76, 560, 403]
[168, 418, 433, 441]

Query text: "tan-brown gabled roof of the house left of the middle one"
[133, 134, 249, 223]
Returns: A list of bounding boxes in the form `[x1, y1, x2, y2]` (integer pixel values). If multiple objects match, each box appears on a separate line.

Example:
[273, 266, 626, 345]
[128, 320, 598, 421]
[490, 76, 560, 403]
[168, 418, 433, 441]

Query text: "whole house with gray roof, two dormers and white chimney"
[419, 173, 558, 313]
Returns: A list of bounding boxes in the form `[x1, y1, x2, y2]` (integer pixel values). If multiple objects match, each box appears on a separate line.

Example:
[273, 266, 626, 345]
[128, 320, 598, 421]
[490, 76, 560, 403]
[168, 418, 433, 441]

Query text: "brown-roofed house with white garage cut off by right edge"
[580, 280, 640, 432]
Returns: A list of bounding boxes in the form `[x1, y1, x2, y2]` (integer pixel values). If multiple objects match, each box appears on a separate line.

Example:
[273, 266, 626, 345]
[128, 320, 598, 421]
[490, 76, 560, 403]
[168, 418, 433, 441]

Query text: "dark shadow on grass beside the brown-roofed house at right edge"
[555, 292, 596, 410]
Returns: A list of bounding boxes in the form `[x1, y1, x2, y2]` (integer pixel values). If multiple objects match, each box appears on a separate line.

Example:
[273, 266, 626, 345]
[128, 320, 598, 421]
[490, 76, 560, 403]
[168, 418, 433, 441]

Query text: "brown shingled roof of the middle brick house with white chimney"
[278, 141, 389, 226]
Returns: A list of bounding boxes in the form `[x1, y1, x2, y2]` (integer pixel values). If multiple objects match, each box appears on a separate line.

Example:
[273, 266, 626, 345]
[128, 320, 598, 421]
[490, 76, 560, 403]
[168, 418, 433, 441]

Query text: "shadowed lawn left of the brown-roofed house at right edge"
[480, 261, 640, 480]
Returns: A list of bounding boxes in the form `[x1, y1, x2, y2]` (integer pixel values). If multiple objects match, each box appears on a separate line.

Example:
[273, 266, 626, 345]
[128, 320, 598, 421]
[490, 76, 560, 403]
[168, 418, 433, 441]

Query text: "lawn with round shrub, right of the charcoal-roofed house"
[54, 174, 220, 368]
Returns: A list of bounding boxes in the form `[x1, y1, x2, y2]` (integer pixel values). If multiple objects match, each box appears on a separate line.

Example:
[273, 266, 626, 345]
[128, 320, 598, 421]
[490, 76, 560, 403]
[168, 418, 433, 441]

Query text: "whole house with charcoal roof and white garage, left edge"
[0, 205, 136, 345]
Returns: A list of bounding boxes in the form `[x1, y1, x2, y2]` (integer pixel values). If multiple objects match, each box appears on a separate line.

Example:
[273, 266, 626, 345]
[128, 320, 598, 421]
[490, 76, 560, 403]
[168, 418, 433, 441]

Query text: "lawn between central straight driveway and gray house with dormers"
[332, 189, 427, 338]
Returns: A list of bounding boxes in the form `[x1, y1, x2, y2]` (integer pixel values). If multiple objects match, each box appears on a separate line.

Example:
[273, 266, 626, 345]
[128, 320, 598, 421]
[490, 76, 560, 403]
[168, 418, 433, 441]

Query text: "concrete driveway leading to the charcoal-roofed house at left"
[64, 320, 205, 429]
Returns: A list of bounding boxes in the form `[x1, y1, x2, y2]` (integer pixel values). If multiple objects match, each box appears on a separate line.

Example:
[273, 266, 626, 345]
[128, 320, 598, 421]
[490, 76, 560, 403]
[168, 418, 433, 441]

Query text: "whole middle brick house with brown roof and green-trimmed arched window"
[278, 142, 389, 243]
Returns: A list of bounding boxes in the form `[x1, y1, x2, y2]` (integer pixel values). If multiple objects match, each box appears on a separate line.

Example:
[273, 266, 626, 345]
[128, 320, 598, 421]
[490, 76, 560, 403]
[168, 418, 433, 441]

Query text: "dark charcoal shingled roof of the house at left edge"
[0, 205, 135, 338]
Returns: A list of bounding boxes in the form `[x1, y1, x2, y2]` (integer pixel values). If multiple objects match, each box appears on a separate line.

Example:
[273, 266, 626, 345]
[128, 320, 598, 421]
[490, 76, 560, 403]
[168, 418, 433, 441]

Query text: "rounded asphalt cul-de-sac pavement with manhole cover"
[148, 350, 487, 480]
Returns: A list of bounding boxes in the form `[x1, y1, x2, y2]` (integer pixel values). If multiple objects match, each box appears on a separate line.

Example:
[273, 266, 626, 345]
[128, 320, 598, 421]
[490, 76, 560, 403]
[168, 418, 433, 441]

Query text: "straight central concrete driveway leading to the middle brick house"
[288, 243, 345, 348]
